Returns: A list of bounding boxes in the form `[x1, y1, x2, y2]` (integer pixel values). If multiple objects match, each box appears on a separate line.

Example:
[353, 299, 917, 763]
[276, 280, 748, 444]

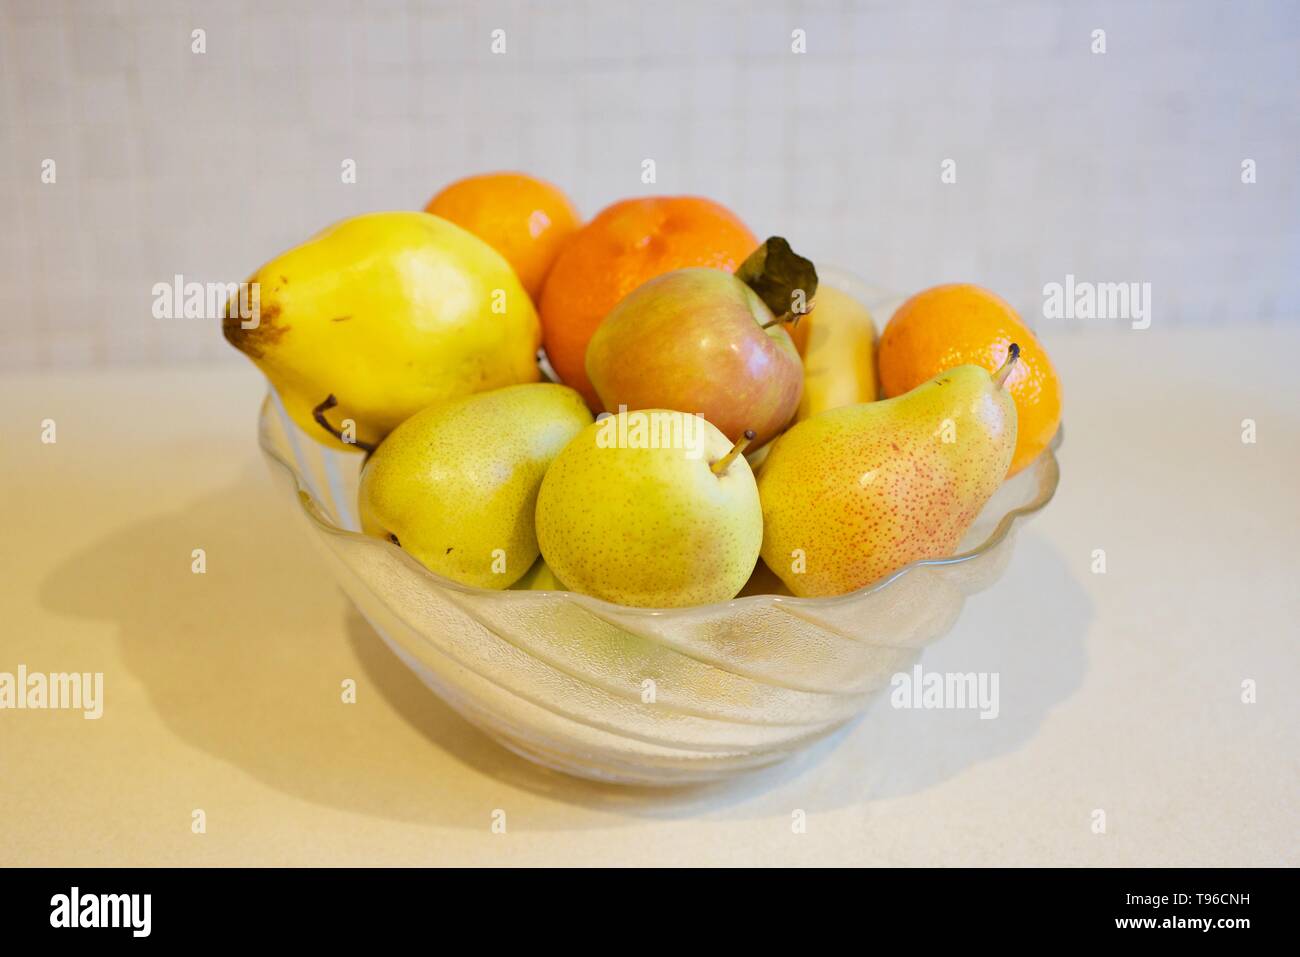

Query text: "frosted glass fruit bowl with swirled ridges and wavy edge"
[259, 269, 1060, 785]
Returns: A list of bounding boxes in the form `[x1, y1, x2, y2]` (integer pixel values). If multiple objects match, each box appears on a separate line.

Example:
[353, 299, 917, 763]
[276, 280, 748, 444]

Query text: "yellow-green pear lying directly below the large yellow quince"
[358, 382, 592, 588]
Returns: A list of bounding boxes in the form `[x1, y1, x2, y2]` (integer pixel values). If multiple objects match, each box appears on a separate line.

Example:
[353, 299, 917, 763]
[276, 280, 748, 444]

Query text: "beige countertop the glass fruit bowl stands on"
[0, 325, 1300, 866]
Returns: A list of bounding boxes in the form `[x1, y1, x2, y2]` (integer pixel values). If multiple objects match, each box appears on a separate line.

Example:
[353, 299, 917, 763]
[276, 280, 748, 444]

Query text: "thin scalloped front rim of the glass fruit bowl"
[257, 403, 1065, 620]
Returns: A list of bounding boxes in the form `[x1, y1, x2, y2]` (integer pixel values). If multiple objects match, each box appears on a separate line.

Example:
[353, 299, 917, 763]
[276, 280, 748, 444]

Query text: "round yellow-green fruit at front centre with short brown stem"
[537, 410, 763, 607]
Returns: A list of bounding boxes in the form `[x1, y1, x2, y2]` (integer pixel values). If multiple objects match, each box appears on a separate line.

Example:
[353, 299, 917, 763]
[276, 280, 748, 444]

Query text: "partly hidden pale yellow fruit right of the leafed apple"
[790, 283, 879, 423]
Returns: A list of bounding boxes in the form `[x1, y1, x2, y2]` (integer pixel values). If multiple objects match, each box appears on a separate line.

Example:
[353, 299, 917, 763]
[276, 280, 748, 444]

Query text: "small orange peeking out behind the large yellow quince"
[424, 173, 581, 303]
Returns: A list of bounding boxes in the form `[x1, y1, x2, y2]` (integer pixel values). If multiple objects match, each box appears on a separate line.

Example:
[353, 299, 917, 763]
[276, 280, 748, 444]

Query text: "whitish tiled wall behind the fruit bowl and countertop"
[0, 0, 1300, 368]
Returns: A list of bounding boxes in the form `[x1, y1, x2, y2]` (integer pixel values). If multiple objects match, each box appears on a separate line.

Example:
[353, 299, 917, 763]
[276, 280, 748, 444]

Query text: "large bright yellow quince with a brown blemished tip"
[222, 212, 541, 450]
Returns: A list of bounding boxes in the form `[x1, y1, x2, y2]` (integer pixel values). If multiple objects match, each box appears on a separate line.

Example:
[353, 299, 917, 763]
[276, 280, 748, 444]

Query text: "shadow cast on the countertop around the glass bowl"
[40, 450, 1092, 832]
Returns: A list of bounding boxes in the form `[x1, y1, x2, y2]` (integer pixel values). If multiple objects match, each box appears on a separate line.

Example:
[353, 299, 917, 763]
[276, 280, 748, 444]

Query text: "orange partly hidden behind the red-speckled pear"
[876, 282, 1061, 476]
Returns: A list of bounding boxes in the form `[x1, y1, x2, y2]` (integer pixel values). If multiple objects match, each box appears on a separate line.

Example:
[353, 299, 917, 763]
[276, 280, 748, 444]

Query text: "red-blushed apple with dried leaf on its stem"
[586, 268, 803, 449]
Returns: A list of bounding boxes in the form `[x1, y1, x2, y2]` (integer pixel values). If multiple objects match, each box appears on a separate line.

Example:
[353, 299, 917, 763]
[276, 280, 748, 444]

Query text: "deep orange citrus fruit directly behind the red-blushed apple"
[538, 196, 758, 411]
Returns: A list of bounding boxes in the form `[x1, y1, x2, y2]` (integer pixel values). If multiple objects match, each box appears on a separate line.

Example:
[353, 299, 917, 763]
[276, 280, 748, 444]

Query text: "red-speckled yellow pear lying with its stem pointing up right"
[758, 343, 1019, 597]
